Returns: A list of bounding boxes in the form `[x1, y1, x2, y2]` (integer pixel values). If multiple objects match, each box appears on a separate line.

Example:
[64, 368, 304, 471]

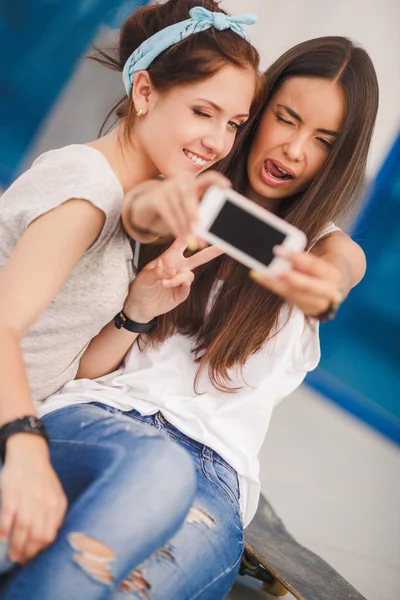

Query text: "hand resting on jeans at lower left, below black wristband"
[0, 433, 67, 564]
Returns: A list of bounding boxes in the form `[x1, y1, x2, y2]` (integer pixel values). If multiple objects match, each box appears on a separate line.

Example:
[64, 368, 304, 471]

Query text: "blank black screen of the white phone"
[209, 199, 286, 266]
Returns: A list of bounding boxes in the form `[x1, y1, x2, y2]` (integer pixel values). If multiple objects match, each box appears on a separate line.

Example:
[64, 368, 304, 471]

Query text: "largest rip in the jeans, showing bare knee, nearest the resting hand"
[68, 532, 116, 583]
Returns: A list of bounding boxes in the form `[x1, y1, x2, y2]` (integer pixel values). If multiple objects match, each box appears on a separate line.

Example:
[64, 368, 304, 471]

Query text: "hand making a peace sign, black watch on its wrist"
[123, 238, 223, 323]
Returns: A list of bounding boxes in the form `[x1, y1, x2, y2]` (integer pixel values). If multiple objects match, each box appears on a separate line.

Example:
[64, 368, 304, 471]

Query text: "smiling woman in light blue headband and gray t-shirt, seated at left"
[0, 0, 260, 600]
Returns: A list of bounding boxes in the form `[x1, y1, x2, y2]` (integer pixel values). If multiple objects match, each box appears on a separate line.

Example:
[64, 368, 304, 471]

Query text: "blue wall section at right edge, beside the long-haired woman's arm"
[307, 136, 400, 443]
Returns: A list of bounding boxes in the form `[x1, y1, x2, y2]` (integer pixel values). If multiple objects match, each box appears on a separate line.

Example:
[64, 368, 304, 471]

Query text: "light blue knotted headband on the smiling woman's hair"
[122, 6, 258, 96]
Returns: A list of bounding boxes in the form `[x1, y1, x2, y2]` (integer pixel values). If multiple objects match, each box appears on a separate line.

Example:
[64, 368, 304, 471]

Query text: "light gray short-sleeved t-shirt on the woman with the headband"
[0, 145, 133, 405]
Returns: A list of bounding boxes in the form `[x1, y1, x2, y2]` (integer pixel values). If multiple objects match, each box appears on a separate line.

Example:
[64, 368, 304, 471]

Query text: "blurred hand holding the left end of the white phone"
[122, 171, 231, 241]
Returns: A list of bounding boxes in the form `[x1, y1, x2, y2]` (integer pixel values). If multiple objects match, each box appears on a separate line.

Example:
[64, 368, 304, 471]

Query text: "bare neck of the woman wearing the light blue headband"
[87, 126, 160, 194]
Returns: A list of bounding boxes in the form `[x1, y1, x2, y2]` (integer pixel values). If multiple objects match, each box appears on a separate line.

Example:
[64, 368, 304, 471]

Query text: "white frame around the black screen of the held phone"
[196, 186, 307, 276]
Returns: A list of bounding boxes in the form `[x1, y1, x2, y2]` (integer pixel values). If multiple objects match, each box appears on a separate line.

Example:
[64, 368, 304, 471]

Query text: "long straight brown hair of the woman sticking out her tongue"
[141, 37, 378, 391]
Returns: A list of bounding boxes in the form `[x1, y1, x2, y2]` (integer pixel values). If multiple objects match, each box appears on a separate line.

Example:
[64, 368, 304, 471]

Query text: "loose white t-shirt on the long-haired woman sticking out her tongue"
[40, 218, 337, 526]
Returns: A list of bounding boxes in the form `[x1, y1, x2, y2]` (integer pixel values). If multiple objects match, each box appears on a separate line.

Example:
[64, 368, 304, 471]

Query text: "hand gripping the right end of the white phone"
[250, 246, 343, 316]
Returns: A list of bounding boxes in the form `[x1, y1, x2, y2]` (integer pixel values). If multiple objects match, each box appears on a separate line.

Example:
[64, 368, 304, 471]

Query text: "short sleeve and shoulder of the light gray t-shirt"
[2, 146, 122, 244]
